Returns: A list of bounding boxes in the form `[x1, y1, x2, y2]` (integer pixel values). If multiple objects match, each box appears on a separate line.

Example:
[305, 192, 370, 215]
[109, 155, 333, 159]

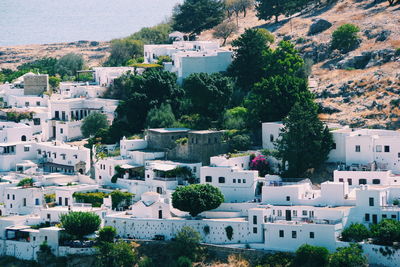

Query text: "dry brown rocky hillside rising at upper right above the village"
[201, 0, 400, 129]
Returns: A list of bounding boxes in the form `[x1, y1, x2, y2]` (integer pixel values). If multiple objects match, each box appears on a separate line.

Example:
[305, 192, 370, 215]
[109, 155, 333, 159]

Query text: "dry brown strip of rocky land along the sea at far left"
[0, 41, 110, 69]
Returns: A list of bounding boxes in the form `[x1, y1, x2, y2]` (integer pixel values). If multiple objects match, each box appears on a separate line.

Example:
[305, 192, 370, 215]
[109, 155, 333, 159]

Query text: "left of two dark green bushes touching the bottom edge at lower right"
[293, 244, 329, 267]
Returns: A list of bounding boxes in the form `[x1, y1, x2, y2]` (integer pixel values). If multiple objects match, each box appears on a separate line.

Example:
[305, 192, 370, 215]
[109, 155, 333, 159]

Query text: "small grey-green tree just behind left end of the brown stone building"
[146, 103, 176, 128]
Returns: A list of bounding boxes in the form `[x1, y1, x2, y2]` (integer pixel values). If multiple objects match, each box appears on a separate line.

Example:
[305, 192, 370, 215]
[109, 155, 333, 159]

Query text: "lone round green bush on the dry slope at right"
[331, 24, 360, 53]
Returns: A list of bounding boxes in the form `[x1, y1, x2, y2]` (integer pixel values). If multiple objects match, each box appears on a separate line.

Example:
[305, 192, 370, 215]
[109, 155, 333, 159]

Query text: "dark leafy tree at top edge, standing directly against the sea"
[172, 0, 225, 36]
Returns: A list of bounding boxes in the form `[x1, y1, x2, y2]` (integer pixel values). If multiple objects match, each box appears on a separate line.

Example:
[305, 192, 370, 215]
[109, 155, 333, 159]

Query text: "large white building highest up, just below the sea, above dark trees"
[144, 41, 232, 83]
